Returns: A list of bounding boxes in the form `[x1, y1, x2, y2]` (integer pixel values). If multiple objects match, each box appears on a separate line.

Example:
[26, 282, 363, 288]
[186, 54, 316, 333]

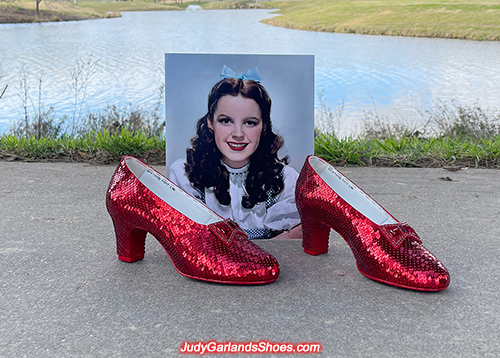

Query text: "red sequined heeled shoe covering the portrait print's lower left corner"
[106, 157, 279, 284]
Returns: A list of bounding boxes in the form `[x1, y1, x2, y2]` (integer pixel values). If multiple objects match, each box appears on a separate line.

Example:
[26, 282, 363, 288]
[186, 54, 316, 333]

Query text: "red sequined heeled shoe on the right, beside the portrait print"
[295, 156, 450, 291]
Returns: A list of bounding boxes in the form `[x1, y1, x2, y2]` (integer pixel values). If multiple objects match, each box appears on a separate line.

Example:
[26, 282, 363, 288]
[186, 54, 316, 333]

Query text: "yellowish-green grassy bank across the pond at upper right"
[263, 0, 500, 41]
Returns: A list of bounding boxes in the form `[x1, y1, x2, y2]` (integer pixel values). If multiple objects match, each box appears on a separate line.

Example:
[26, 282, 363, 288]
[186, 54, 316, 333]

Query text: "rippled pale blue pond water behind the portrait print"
[0, 10, 500, 133]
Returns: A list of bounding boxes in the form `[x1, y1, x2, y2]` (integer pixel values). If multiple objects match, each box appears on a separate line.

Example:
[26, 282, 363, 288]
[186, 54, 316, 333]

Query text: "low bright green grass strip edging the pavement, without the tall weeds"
[0, 129, 500, 168]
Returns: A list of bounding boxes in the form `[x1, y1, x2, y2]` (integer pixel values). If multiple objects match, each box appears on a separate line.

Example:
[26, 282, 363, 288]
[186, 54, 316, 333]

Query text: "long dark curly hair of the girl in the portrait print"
[185, 78, 288, 209]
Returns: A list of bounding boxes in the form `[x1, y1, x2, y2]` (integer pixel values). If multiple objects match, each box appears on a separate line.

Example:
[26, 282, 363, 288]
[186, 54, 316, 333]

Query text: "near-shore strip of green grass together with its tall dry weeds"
[0, 100, 500, 168]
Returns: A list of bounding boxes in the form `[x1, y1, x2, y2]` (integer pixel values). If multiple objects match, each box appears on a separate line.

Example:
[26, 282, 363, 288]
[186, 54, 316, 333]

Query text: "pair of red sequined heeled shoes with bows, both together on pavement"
[106, 156, 450, 291]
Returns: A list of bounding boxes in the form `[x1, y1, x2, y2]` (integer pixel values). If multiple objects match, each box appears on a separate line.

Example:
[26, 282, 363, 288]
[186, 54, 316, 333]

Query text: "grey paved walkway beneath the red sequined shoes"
[0, 162, 500, 358]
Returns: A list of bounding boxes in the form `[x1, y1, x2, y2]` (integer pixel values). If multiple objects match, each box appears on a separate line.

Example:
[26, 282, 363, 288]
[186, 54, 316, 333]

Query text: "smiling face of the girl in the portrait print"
[207, 95, 263, 168]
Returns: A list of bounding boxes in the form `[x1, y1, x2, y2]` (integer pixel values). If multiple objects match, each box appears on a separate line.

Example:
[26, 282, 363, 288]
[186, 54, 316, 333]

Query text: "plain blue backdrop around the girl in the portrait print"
[165, 53, 314, 173]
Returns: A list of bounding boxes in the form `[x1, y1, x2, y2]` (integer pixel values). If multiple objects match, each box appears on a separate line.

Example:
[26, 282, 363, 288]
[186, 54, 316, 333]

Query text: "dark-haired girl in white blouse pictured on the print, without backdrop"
[169, 69, 301, 239]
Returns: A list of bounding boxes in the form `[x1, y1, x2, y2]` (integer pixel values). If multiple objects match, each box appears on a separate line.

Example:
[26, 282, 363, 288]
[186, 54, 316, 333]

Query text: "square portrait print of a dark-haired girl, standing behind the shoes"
[165, 54, 314, 239]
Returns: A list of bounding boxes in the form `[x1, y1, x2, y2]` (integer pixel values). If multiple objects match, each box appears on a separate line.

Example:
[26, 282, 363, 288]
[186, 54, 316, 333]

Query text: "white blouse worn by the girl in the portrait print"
[168, 159, 300, 239]
